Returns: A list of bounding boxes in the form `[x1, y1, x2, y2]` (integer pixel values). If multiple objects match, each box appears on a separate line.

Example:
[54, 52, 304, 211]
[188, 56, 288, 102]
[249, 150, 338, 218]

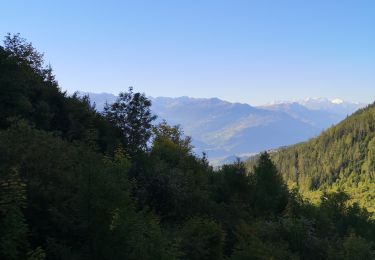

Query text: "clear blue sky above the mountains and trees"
[0, 0, 375, 105]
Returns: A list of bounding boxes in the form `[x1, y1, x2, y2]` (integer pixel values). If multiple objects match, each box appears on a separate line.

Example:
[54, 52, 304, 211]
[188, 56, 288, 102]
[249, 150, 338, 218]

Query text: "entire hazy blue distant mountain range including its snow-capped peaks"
[81, 93, 366, 164]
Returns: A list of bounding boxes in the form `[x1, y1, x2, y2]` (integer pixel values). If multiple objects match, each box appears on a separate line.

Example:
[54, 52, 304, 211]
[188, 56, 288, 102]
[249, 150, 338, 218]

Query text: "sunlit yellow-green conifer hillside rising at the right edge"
[248, 104, 375, 212]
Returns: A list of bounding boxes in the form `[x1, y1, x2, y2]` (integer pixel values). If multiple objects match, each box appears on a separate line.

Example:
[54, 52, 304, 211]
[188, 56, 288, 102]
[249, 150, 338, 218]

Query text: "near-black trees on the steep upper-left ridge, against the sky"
[0, 35, 121, 152]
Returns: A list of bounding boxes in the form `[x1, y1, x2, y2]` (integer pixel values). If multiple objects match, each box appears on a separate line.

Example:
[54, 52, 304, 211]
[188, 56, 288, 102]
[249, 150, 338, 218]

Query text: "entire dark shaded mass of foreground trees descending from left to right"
[0, 35, 375, 259]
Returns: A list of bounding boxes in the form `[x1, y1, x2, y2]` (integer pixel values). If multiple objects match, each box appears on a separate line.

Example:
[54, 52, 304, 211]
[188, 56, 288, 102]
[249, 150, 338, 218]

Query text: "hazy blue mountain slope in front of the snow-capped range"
[152, 97, 319, 157]
